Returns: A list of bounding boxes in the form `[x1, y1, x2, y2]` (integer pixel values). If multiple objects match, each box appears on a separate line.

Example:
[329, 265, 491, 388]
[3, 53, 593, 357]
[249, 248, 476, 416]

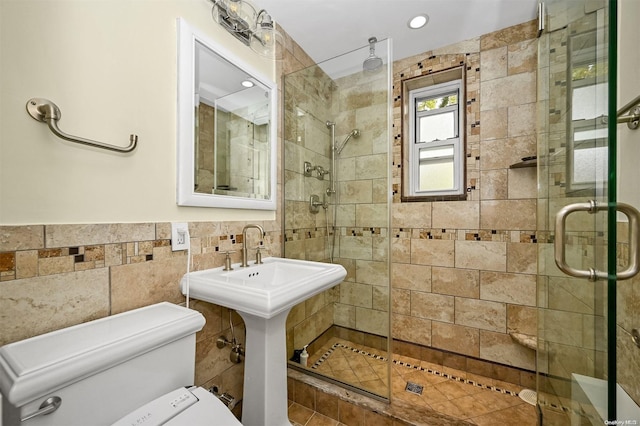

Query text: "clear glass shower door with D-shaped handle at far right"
[537, 0, 640, 425]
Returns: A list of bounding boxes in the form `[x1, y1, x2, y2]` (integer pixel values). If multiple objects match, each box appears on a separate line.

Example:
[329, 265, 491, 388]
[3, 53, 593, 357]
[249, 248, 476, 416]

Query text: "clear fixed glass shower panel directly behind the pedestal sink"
[283, 40, 391, 399]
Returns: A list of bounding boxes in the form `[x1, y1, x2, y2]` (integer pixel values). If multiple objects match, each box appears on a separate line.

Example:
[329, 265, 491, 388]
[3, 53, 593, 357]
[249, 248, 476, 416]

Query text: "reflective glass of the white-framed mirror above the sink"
[198, 42, 270, 199]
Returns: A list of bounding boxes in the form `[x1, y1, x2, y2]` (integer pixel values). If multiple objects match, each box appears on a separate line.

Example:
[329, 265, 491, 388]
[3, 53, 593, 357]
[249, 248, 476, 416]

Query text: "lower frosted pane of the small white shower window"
[418, 145, 454, 191]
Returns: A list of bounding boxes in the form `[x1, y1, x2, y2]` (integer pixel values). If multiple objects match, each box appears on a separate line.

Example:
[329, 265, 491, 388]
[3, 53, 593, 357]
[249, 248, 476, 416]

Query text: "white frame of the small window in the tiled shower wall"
[407, 79, 465, 197]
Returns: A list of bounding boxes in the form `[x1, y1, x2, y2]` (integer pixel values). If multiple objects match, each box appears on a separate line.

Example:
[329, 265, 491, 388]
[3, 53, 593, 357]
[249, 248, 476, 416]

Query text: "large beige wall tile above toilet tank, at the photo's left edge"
[0, 268, 109, 346]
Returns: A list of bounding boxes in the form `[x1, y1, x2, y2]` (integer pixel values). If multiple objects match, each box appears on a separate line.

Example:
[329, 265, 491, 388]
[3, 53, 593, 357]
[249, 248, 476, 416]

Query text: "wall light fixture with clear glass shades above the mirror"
[211, 0, 282, 60]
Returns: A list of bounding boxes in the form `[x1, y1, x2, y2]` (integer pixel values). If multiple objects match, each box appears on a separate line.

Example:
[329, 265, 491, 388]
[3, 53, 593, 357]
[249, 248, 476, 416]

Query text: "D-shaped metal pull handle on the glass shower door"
[554, 200, 640, 281]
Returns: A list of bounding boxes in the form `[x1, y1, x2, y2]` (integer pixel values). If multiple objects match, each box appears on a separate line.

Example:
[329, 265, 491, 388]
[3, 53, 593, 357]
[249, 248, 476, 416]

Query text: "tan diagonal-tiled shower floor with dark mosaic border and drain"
[297, 338, 536, 425]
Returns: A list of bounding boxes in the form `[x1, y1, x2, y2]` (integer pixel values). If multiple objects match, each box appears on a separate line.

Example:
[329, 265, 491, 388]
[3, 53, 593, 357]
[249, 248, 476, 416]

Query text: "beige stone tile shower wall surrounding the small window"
[391, 22, 537, 370]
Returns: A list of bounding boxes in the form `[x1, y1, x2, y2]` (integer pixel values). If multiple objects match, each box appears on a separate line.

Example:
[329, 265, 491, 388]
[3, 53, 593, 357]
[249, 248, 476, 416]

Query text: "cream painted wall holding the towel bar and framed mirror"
[0, 0, 275, 225]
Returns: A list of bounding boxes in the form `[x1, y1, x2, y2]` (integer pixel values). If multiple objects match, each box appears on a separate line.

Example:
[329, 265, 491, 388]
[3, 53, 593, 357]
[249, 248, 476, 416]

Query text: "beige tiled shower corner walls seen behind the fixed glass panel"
[283, 43, 389, 354]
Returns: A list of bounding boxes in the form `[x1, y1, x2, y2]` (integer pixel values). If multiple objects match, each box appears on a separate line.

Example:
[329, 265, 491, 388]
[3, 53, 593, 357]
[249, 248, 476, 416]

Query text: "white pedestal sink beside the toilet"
[181, 257, 347, 426]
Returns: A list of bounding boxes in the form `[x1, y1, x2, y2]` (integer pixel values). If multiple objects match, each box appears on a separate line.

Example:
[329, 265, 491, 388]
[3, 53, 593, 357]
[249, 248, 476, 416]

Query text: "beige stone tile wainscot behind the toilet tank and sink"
[0, 222, 281, 397]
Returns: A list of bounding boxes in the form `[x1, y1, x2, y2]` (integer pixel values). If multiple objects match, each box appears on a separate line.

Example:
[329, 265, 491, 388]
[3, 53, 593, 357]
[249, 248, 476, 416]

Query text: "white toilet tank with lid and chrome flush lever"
[0, 302, 205, 426]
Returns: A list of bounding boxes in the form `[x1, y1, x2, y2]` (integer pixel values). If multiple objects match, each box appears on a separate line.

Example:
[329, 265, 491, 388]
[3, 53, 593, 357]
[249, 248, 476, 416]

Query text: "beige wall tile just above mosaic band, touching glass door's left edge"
[480, 200, 536, 230]
